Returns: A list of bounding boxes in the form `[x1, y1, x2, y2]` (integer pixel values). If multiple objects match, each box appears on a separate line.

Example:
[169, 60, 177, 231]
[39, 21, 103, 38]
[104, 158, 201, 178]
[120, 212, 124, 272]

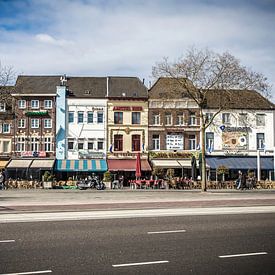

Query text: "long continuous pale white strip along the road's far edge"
[0, 206, 275, 223]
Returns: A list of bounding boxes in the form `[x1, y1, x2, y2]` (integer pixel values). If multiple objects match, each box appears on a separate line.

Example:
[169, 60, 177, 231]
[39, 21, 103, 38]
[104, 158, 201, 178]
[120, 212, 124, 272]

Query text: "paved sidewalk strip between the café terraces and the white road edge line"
[0, 189, 275, 214]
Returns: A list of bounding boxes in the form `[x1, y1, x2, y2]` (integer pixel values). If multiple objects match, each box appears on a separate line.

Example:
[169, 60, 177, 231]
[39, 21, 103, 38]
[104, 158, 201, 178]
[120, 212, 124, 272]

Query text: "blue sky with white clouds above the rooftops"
[0, 0, 275, 101]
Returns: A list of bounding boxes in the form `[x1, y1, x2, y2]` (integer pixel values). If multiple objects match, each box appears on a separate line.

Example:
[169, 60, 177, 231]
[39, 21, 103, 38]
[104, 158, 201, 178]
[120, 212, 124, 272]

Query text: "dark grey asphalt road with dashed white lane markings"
[0, 213, 275, 274]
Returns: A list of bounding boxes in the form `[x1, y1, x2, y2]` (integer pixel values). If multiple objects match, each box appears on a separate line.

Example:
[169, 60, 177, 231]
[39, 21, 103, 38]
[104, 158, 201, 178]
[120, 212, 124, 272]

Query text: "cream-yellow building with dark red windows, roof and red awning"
[107, 77, 151, 185]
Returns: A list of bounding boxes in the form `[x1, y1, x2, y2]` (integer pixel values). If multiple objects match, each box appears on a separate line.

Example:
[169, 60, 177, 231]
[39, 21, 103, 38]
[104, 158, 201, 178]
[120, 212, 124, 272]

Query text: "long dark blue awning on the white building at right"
[206, 156, 274, 170]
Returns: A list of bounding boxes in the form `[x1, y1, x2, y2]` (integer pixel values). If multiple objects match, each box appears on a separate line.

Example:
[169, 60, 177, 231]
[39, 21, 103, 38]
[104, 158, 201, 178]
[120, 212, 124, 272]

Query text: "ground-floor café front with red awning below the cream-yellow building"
[108, 159, 152, 186]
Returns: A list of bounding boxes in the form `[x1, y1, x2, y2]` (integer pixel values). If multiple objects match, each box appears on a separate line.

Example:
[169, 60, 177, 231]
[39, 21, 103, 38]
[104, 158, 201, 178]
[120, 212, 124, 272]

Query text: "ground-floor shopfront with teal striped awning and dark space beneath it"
[55, 159, 108, 180]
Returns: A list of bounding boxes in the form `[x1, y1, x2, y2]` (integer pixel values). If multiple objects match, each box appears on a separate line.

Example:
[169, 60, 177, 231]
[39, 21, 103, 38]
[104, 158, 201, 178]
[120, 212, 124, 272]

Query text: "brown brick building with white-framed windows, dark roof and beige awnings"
[7, 76, 59, 178]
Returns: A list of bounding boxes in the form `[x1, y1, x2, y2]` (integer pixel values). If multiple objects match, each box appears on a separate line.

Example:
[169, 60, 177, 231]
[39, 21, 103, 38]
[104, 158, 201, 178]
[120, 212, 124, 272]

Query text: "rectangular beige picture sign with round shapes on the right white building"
[222, 132, 248, 151]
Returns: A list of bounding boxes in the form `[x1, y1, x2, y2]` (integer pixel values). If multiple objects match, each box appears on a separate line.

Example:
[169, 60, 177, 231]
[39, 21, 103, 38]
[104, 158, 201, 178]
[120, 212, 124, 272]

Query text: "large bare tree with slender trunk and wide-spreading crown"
[152, 48, 271, 191]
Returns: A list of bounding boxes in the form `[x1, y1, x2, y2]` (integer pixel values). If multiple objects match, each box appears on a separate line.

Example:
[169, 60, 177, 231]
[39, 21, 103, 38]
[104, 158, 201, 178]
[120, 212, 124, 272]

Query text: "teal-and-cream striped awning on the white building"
[55, 159, 107, 172]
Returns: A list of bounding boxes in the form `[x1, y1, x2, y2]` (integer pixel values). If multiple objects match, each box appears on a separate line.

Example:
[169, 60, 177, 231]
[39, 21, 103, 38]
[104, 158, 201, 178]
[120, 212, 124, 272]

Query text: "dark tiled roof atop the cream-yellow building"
[108, 76, 148, 99]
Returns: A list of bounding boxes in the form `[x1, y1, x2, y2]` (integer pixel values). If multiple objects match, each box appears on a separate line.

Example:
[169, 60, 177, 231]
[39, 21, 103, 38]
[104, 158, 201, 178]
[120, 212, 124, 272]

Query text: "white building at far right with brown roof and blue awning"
[204, 90, 275, 182]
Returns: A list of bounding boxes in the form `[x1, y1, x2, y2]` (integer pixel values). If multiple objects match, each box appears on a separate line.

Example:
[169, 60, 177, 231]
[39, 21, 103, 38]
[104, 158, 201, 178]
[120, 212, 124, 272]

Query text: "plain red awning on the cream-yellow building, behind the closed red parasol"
[108, 159, 151, 171]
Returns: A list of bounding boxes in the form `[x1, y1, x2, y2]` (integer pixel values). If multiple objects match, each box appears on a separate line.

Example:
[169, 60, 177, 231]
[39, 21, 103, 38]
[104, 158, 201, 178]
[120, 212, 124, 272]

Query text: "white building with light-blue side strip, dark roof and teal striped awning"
[56, 77, 107, 181]
